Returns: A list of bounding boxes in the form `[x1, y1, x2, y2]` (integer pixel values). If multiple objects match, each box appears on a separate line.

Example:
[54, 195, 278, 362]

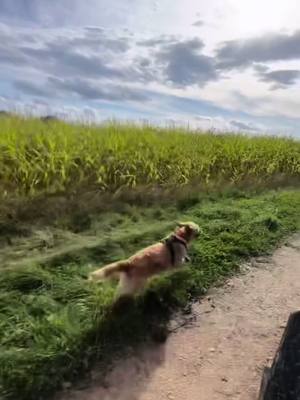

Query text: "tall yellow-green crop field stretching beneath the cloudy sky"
[0, 117, 300, 196]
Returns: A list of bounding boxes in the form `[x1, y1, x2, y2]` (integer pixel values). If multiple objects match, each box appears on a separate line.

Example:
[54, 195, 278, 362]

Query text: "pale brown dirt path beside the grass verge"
[61, 236, 300, 400]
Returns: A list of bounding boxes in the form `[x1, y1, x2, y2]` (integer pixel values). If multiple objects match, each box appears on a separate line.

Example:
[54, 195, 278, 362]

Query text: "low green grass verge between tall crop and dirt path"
[0, 188, 300, 400]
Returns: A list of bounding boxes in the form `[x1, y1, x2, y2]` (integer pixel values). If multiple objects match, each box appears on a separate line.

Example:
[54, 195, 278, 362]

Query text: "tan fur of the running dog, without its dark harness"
[89, 222, 199, 296]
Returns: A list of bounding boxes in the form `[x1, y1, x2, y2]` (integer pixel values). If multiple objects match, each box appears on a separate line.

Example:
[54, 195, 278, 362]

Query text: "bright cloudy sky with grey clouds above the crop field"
[0, 0, 300, 137]
